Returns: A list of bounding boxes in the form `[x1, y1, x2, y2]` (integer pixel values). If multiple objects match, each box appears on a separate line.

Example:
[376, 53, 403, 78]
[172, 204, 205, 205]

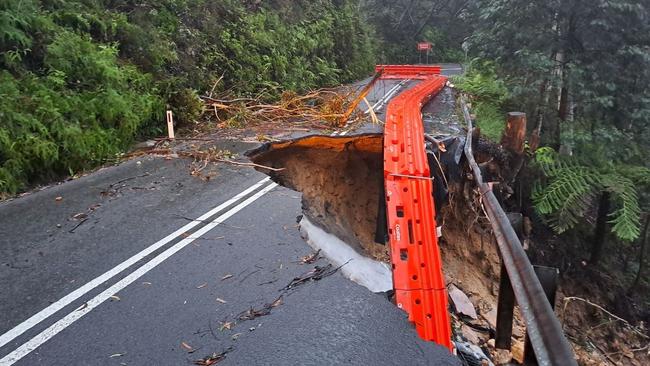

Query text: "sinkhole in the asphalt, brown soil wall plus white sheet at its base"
[246, 133, 392, 292]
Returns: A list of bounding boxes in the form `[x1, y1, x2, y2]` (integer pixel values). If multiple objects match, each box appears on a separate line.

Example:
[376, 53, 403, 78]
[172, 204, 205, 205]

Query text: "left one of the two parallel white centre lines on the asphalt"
[0, 177, 270, 347]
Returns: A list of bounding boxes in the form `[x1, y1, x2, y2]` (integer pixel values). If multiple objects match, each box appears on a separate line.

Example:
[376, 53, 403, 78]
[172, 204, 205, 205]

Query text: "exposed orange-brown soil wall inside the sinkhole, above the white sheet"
[246, 134, 389, 261]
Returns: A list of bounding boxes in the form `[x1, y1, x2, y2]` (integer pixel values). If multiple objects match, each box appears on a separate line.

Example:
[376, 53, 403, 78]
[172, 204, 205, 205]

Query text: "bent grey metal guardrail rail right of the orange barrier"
[461, 97, 577, 366]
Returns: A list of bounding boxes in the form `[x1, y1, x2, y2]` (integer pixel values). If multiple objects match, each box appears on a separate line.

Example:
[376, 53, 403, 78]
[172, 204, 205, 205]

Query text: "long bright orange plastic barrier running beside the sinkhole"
[380, 66, 452, 350]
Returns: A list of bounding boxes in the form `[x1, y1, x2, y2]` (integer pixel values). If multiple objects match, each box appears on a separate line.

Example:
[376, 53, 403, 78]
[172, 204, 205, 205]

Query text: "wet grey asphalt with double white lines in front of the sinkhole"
[0, 66, 458, 366]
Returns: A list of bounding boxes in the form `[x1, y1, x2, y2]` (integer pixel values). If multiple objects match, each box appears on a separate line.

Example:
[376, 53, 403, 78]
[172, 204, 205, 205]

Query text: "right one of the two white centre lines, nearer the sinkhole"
[0, 183, 278, 366]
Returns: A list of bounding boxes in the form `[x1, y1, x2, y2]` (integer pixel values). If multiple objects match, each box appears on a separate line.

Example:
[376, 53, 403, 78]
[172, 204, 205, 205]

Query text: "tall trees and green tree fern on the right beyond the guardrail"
[469, 0, 650, 246]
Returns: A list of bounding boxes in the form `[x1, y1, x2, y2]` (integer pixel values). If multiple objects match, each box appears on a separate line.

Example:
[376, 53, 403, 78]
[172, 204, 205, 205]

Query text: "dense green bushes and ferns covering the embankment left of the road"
[0, 0, 375, 193]
